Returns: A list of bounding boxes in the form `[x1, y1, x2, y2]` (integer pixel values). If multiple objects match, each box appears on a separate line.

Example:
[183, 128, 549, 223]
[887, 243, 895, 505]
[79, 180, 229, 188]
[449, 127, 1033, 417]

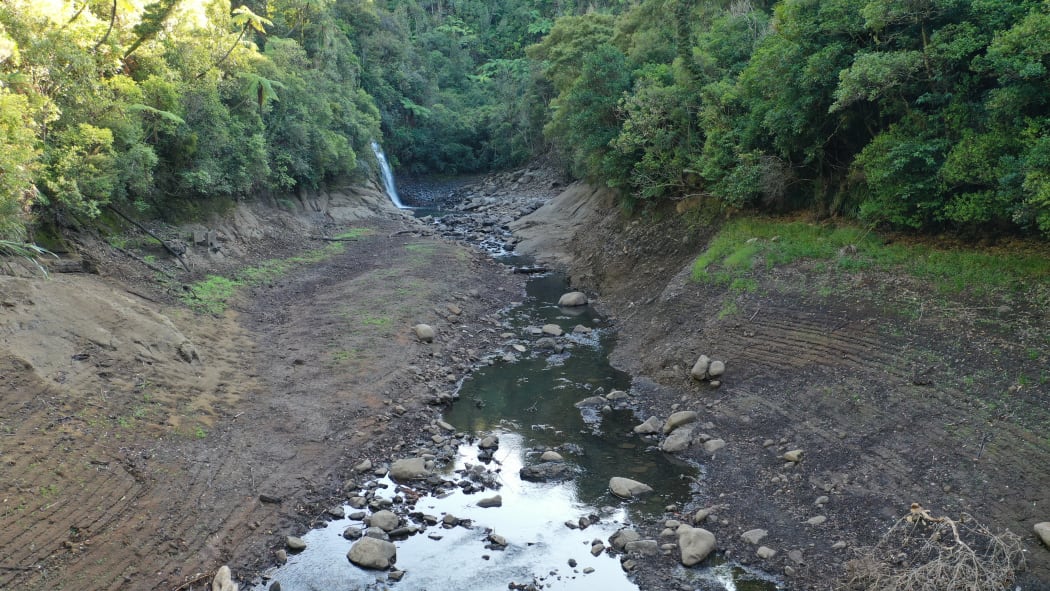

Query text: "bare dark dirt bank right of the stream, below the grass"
[516, 182, 1050, 590]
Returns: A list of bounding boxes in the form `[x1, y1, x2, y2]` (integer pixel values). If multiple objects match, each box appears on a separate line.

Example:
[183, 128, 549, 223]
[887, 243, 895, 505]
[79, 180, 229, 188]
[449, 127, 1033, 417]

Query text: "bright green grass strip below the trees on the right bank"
[692, 217, 1050, 295]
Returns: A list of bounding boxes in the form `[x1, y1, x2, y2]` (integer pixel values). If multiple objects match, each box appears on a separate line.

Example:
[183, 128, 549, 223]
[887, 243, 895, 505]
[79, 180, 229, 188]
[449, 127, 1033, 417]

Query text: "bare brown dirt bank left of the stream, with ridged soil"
[0, 185, 521, 590]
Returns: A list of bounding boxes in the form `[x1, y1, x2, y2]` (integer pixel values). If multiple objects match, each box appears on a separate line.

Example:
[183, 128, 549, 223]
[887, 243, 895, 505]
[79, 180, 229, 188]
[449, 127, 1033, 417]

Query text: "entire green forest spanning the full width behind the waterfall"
[0, 0, 1050, 239]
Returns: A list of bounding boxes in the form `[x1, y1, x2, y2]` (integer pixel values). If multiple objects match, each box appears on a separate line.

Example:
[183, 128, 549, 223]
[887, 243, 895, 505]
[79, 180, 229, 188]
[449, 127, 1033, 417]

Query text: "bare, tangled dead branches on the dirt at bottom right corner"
[844, 503, 1025, 591]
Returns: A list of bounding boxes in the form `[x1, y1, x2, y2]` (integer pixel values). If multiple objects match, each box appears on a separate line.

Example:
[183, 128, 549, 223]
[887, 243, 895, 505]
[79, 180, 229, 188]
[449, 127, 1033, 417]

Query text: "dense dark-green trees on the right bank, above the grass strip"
[530, 0, 1050, 233]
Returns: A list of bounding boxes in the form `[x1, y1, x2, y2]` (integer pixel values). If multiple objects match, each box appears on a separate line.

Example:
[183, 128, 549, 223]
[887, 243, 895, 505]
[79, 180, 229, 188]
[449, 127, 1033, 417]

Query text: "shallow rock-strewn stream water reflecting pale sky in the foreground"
[256, 268, 776, 591]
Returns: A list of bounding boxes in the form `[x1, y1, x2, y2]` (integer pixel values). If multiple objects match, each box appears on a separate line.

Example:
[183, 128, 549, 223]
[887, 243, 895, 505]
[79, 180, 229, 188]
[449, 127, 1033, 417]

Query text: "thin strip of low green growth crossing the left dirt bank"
[181, 228, 374, 316]
